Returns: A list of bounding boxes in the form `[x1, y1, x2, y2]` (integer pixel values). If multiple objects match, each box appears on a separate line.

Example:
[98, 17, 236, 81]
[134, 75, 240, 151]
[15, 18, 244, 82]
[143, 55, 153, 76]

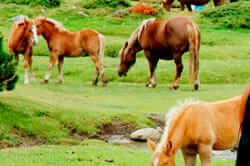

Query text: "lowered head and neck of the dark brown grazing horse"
[118, 29, 141, 77]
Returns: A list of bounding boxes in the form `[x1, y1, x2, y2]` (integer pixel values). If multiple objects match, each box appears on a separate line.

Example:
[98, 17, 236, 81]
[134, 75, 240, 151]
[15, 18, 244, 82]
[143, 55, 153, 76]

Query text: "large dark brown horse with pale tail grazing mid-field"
[118, 17, 200, 90]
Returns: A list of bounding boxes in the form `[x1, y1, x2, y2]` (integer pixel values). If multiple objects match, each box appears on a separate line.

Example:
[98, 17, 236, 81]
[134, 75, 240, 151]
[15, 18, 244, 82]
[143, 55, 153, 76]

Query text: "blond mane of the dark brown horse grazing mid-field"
[128, 18, 155, 46]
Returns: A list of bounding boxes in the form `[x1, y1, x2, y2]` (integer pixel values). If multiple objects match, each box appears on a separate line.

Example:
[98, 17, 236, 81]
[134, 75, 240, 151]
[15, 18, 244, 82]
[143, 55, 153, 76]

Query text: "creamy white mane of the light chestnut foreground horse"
[155, 99, 202, 153]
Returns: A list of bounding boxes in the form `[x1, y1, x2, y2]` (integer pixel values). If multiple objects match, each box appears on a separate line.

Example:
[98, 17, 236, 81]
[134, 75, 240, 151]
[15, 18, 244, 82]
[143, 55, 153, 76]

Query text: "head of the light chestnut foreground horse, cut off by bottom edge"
[147, 140, 175, 166]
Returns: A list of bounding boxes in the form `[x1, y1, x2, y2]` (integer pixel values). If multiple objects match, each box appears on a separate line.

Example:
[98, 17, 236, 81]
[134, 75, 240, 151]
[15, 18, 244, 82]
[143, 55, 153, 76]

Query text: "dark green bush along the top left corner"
[1, 0, 62, 8]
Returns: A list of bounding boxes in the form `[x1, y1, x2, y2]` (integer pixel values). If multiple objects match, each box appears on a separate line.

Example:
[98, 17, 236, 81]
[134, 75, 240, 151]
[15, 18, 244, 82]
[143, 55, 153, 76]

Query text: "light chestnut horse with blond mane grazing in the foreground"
[148, 86, 250, 166]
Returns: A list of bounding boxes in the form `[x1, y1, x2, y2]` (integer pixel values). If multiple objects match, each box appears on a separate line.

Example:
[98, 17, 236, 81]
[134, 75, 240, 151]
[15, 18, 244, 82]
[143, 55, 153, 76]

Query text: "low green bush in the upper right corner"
[201, 1, 250, 29]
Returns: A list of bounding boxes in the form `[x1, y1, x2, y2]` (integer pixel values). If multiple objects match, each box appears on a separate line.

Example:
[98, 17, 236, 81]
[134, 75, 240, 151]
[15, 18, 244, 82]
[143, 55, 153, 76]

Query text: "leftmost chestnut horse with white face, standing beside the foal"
[8, 19, 38, 84]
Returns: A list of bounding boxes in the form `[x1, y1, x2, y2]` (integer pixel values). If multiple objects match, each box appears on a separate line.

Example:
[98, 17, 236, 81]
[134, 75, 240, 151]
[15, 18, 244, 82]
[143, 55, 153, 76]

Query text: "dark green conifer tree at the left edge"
[0, 32, 18, 91]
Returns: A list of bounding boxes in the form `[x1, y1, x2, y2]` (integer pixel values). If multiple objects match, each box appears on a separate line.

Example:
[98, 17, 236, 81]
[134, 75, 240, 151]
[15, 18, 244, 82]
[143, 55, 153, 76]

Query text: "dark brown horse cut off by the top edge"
[162, 0, 225, 12]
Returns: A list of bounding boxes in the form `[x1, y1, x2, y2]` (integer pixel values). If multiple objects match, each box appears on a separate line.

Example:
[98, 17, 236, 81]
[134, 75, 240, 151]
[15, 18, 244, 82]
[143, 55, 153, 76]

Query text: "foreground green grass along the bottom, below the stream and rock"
[0, 140, 234, 166]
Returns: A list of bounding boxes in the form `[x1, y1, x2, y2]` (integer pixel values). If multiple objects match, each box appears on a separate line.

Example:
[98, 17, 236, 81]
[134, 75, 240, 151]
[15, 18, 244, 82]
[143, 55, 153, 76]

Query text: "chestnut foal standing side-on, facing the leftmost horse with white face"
[34, 17, 107, 85]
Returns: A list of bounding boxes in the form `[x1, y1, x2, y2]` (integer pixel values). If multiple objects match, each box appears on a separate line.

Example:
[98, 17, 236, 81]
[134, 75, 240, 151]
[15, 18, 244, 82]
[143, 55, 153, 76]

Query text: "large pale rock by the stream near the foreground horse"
[130, 128, 161, 141]
